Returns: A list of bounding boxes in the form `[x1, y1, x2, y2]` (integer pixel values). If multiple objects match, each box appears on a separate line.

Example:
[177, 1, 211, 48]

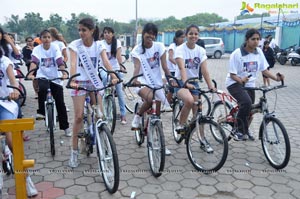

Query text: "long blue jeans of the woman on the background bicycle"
[100, 70, 126, 117]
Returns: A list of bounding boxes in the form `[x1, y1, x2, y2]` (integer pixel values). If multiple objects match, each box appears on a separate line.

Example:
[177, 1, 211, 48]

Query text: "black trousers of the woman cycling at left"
[37, 79, 69, 130]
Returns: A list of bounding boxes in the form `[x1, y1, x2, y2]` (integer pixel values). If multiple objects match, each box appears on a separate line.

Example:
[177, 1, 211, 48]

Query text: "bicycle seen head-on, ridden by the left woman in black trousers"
[25, 68, 69, 156]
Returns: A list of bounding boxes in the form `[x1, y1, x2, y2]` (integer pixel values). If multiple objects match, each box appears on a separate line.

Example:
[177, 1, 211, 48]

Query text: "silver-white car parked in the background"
[200, 37, 225, 59]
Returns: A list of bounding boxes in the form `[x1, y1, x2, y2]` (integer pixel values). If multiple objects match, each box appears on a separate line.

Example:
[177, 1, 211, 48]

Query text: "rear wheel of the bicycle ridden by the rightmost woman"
[210, 101, 233, 141]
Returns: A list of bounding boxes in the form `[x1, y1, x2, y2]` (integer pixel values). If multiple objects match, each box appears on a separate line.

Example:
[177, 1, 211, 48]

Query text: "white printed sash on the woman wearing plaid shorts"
[77, 43, 103, 89]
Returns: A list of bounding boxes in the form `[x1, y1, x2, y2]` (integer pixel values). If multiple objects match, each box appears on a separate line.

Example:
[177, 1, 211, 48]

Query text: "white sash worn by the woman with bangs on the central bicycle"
[140, 55, 170, 107]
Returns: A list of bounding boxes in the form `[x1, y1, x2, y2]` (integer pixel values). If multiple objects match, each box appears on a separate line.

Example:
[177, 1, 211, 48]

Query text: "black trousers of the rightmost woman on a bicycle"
[227, 83, 255, 134]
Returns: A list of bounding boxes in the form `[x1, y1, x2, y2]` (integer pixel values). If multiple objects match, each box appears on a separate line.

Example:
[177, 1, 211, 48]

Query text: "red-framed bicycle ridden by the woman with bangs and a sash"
[124, 74, 165, 177]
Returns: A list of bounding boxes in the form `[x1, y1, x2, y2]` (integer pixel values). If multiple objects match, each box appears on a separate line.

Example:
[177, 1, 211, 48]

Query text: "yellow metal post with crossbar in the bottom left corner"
[0, 118, 34, 199]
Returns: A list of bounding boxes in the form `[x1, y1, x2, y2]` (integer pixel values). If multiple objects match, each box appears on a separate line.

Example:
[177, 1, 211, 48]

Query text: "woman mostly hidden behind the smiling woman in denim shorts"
[167, 30, 185, 103]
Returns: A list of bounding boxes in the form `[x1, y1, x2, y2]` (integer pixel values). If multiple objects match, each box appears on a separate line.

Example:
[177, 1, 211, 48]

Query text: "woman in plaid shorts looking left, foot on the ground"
[69, 18, 118, 168]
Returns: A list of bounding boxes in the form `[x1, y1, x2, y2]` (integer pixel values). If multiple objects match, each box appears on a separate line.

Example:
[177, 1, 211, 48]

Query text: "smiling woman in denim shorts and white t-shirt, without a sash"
[175, 25, 214, 152]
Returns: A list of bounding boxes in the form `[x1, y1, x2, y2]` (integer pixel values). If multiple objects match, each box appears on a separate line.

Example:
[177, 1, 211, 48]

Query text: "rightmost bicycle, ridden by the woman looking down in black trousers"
[211, 78, 291, 169]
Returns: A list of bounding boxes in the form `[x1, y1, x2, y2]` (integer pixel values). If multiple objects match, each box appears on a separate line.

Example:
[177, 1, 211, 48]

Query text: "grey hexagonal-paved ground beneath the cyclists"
[4, 57, 300, 199]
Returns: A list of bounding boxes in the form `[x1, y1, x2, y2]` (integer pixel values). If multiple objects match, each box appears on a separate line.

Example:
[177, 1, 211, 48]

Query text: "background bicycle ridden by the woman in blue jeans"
[101, 64, 127, 135]
